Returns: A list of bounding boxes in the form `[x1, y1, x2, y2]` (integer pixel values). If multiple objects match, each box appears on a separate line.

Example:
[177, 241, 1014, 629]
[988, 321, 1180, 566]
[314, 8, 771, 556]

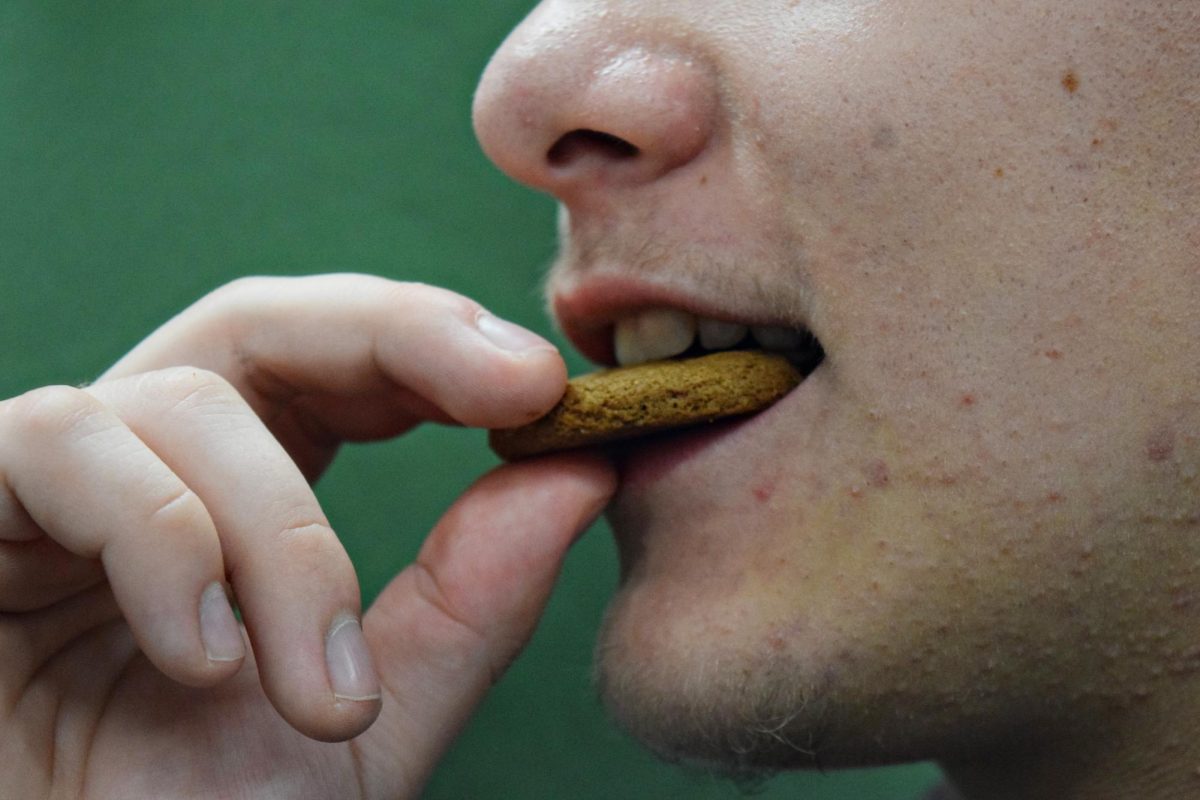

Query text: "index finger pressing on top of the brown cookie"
[101, 275, 566, 470]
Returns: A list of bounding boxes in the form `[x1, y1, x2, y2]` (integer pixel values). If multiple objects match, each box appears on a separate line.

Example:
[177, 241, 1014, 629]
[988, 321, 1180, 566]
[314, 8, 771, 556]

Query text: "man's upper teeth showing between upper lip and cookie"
[613, 308, 811, 367]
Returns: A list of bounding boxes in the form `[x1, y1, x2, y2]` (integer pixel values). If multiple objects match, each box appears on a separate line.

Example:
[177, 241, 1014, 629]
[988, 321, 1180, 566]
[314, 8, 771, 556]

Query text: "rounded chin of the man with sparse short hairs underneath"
[585, 510, 878, 776]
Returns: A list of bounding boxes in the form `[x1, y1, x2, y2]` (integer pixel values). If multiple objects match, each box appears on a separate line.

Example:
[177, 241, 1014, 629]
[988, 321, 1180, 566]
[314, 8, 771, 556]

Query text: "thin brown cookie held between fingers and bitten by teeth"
[488, 350, 803, 461]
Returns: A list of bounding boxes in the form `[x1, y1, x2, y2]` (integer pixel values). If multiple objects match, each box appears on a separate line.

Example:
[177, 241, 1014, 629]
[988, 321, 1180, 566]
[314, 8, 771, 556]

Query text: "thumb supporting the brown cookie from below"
[358, 455, 617, 798]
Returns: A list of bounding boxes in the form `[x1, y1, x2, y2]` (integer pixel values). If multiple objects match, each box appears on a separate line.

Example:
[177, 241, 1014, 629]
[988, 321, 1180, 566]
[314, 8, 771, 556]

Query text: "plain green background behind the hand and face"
[0, 0, 936, 800]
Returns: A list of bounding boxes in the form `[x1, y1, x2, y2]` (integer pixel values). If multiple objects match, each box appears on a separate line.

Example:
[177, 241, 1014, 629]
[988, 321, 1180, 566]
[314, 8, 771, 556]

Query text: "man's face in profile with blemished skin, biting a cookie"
[476, 0, 1200, 765]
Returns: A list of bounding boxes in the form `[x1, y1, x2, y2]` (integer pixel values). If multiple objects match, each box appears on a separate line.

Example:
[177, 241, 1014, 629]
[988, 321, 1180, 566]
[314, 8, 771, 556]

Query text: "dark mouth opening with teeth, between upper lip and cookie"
[612, 308, 824, 375]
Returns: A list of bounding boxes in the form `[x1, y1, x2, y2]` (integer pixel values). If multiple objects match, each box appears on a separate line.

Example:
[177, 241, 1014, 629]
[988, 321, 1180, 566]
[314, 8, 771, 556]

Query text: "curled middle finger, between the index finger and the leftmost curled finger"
[89, 367, 379, 739]
